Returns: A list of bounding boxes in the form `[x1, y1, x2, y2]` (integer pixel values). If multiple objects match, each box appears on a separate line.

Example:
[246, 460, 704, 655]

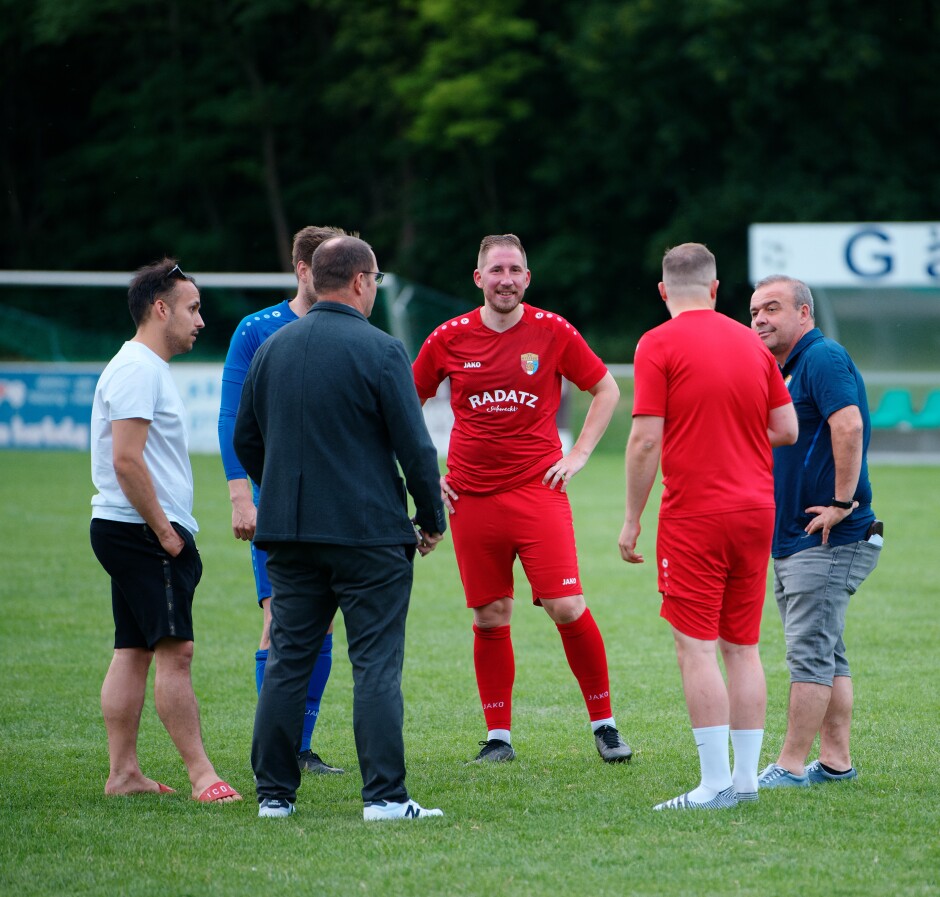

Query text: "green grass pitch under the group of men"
[0, 452, 940, 897]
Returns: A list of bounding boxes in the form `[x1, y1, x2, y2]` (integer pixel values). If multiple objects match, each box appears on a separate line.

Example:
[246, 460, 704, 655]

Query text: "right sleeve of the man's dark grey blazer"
[380, 341, 447, 533]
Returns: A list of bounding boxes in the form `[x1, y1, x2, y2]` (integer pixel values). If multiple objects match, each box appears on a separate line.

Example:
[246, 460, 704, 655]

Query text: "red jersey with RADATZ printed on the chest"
[413, 303, 607, 495]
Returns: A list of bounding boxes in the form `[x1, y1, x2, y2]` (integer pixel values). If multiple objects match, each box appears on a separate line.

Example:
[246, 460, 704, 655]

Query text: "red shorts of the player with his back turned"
[656, 508, 774, 645]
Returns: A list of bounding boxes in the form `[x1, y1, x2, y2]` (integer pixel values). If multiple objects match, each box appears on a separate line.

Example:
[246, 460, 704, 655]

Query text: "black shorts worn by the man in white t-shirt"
[91, 517, 202, 650]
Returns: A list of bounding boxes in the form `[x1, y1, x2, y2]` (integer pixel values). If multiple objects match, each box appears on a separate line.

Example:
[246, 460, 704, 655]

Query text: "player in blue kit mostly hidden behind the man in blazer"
[219, 227, 345, 774]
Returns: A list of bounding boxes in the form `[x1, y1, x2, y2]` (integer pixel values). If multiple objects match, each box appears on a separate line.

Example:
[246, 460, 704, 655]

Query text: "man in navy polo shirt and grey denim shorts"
[751, 275, 883, 788]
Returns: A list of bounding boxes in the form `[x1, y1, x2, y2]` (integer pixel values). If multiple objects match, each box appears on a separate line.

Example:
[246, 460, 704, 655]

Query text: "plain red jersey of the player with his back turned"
[633, 309, 790, 517]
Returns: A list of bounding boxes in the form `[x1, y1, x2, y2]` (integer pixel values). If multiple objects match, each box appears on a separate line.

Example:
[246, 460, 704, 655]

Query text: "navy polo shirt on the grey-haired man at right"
[771, 327, 875, 558]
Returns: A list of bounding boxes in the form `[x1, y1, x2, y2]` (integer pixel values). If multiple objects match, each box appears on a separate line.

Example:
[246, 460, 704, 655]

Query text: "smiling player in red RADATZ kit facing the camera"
[414, 234, 632, 763]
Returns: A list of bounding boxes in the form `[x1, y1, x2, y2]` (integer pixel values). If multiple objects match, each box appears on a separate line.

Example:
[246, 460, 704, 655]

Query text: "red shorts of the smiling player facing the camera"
[450, 477, 582, 607]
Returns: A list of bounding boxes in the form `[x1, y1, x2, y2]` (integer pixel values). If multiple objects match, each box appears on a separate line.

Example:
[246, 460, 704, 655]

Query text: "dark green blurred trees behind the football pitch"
[0, 0, 940, 361]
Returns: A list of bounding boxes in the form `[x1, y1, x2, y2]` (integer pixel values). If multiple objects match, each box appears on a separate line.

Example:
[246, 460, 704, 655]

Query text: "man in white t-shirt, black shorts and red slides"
[91, 259, 241, 803]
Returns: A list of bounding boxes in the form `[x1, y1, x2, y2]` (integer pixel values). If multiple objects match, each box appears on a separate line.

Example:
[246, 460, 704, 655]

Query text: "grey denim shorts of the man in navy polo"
[774, 542, 881, 685]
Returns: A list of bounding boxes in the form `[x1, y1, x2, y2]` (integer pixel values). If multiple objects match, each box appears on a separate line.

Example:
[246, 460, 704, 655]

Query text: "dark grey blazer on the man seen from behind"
[233, 302, 447, 548]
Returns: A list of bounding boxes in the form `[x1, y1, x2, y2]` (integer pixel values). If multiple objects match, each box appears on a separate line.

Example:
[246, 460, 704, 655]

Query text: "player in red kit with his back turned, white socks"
[619, 243, 797, 810]
